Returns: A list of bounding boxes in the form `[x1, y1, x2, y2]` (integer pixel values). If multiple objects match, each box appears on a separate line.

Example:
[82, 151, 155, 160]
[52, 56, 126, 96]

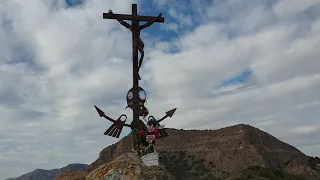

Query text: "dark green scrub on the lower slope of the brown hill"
[159, 152, 306, 180]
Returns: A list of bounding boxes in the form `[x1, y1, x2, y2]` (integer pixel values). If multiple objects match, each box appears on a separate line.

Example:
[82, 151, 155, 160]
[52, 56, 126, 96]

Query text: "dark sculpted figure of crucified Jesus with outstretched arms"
[109, 9, 162, 80]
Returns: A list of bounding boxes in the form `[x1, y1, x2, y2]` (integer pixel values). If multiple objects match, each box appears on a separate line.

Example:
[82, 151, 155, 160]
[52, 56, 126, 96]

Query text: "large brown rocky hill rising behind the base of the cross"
[59, 124, 320, 180]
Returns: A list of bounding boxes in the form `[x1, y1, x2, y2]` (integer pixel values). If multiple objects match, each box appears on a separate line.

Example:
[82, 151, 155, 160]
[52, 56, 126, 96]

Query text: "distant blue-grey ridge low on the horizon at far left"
[7, 164, 88, 180]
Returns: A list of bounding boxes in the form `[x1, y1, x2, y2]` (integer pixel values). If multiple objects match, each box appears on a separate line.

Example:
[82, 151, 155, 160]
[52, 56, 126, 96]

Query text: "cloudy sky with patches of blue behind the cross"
[0, 0, 320, 179]
